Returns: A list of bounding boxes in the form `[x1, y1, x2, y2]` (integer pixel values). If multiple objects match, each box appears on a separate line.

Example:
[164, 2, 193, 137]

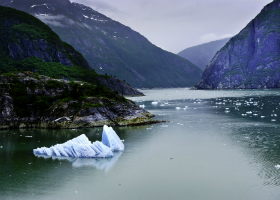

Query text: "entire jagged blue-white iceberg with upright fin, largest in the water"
[33, 125, 124, 158]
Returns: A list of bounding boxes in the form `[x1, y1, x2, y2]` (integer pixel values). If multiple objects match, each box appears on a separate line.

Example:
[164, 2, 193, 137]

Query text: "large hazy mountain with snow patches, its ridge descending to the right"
[0, 0, 202, 87]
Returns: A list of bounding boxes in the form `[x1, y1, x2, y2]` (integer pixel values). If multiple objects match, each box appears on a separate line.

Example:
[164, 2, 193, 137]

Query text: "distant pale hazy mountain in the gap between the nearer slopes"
[178, 38, 230, 70]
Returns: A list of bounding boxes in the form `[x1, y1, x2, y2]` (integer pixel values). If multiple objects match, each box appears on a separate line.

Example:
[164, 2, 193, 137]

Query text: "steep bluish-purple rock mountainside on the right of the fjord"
[195, 0, 280, 89]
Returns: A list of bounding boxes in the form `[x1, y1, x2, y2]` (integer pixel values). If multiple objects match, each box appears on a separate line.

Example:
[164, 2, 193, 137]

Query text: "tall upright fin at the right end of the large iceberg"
[102, 125, 124, 151]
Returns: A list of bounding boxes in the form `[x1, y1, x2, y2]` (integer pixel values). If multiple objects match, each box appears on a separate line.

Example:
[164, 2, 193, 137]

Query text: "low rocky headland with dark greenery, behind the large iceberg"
[0, 72, 157, 129]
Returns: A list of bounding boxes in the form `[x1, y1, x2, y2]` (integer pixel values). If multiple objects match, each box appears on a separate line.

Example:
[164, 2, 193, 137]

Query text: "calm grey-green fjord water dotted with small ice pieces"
[0, 89, 280, 200]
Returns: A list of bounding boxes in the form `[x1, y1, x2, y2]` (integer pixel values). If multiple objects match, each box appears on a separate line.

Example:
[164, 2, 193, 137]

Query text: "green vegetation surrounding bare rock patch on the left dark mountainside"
[0, 6, 95, 83]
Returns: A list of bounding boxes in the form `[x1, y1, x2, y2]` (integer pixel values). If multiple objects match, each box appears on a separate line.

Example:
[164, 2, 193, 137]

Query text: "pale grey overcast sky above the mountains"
[71, 0, 272, 53]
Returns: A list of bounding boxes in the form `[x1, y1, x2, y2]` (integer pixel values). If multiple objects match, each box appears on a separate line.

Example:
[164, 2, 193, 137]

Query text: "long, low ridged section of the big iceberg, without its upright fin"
[33, 134, 113, 158]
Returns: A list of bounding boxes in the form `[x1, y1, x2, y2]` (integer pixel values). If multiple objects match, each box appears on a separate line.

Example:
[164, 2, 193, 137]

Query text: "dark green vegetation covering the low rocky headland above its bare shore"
[0, 72, 127, 117]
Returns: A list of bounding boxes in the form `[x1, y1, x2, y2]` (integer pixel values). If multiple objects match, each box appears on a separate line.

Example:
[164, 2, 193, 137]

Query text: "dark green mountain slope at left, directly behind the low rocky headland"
[0, 6, 142, 95]
